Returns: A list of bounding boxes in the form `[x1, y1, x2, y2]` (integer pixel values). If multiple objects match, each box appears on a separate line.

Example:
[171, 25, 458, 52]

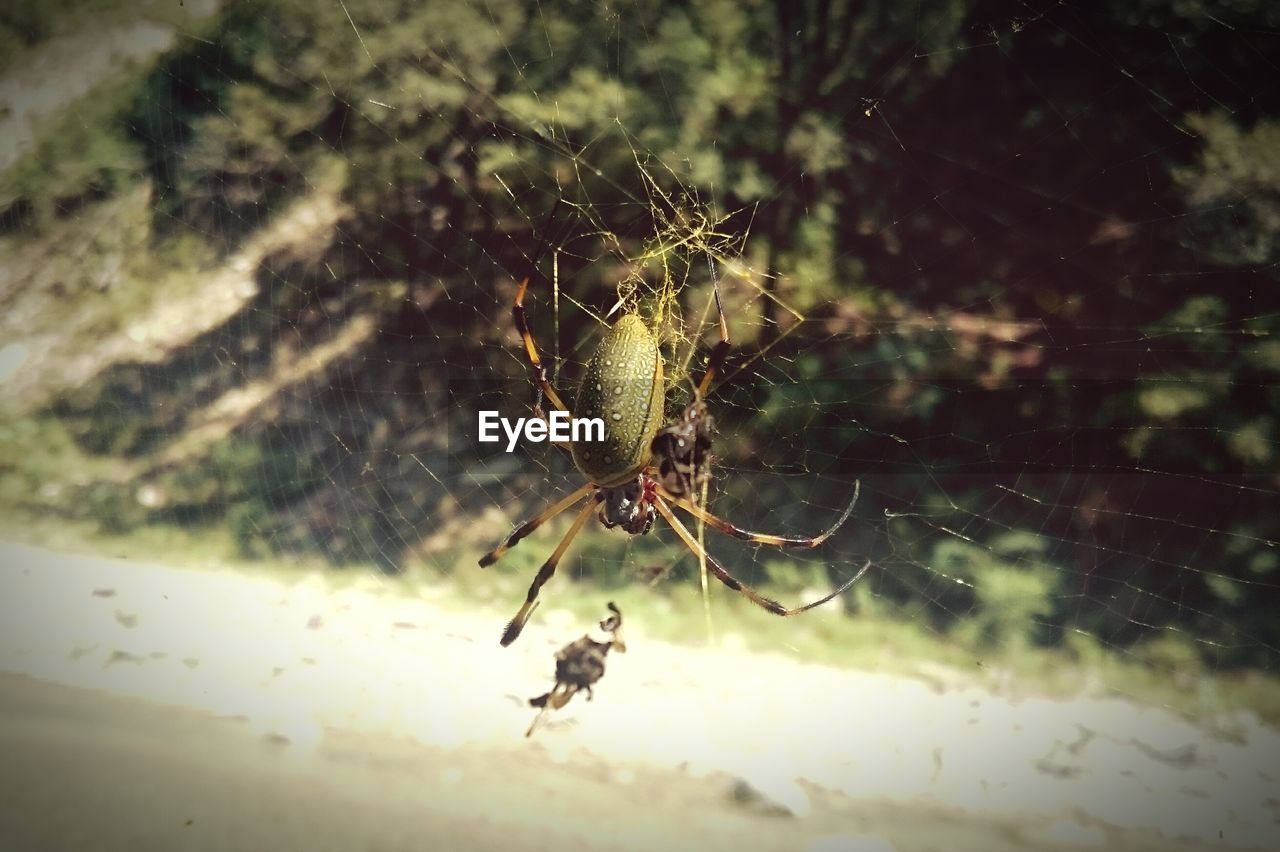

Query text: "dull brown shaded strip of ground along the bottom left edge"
[0, 674, 880, 852]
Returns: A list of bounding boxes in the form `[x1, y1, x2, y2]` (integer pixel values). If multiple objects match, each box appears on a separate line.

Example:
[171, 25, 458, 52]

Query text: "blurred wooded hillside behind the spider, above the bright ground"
[0, 0, 1280, 848]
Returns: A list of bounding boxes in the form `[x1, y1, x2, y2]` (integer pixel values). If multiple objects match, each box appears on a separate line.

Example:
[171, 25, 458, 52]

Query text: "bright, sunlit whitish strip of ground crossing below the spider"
[0, 545, 1280, 848]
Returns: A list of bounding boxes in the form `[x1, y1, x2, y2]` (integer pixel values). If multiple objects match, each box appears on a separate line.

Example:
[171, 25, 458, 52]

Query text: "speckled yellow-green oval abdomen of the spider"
[573, 313, 663, 487]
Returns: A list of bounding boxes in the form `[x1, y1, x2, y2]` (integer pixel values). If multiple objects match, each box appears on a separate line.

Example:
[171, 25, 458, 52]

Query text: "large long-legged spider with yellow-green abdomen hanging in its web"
[480, 258, 870, 646]
